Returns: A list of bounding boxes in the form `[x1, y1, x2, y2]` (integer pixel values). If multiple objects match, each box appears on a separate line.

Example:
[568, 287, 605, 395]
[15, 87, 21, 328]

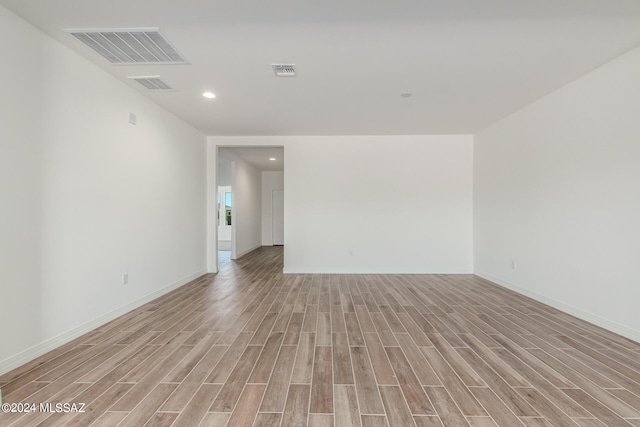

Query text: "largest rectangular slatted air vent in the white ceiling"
[64, 28, 187, 65]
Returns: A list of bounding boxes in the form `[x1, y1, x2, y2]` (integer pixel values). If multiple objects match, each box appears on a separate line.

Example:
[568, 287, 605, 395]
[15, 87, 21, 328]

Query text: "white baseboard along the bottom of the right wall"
[475, 271, 640, 342]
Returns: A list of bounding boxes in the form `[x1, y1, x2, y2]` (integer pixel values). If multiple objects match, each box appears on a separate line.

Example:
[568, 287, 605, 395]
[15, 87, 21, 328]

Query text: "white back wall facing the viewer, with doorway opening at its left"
[208, 135, 473, 273]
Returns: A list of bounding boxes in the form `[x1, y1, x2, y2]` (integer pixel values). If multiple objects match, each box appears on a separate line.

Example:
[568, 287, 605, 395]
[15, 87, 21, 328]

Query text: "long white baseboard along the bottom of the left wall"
[0, 270, 207, 375]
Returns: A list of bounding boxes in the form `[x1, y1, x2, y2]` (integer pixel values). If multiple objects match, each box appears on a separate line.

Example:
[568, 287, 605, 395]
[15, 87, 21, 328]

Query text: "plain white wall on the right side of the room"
[474, 45, 640, 341]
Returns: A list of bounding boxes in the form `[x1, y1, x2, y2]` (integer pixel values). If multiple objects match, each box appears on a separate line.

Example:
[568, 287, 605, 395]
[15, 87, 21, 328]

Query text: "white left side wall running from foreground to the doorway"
[0, 7, 206, 372]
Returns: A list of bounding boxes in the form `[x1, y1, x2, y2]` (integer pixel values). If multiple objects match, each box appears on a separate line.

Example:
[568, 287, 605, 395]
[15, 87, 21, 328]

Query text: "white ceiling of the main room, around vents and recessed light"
[0, 0, 640, 135]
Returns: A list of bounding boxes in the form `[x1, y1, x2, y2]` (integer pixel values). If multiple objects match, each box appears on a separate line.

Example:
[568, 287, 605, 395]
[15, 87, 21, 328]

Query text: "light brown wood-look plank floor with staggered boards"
[0, 248, 640, 427]
